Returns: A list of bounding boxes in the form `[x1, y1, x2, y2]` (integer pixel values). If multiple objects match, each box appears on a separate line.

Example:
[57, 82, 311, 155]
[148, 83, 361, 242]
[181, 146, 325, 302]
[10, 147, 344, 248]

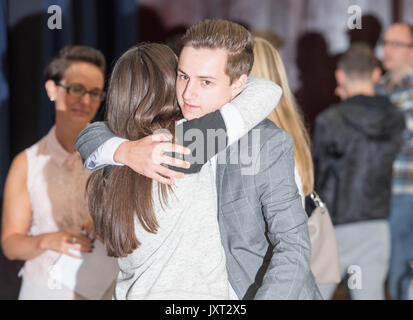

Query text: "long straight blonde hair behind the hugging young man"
[251, 37, 314, 195]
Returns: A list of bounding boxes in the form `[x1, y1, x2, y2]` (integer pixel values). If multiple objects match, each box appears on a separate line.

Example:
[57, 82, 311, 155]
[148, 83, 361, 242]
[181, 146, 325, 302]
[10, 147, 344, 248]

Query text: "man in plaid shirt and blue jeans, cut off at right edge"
[376, 23, 413, 299]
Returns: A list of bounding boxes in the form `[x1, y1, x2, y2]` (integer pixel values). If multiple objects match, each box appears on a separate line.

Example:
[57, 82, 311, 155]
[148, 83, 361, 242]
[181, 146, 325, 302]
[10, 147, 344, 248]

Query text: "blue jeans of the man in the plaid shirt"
[389, 194, 413, 300]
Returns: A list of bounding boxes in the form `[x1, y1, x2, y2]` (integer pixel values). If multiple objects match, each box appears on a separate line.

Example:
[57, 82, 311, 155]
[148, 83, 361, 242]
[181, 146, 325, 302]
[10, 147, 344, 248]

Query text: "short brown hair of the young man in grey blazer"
[178, 19, 254, 83]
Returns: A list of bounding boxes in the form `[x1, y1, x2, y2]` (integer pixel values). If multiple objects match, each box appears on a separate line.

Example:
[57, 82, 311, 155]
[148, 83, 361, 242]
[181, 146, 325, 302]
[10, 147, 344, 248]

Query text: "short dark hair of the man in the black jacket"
[338, 42, 380, 80]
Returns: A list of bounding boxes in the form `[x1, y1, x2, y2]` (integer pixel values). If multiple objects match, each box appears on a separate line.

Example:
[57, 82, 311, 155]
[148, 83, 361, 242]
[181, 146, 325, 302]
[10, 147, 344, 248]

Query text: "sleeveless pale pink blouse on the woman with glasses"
[19, 127, 90, 298]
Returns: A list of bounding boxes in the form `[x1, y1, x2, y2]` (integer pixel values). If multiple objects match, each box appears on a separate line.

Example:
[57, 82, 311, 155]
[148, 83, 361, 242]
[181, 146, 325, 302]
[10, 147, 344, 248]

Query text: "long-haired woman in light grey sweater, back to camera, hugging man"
[87, 44, 280, 299]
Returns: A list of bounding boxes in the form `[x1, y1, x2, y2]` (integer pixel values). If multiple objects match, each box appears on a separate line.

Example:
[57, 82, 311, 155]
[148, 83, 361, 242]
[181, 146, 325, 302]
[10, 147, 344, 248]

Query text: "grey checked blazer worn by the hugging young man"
[76, 119, 322, 300]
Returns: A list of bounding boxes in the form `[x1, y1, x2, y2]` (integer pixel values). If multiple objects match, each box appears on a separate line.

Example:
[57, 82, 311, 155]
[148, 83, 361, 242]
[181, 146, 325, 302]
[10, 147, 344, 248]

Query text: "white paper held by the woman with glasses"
[49, 239, 119, 300]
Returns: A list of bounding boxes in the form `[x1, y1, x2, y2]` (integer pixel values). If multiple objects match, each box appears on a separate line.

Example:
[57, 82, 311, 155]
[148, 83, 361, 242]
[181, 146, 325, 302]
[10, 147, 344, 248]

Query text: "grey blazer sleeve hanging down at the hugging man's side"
[251, 130, 321, 300]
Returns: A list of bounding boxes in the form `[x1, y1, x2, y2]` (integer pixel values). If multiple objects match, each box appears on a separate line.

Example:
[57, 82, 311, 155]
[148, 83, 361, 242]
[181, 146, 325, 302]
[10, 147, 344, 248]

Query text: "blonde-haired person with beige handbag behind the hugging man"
[251, 37, 338, 283]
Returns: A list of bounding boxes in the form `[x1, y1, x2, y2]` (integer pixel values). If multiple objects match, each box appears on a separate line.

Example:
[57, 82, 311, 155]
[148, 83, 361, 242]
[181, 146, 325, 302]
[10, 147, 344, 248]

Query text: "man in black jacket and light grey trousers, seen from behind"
[313, 43, 405, 299]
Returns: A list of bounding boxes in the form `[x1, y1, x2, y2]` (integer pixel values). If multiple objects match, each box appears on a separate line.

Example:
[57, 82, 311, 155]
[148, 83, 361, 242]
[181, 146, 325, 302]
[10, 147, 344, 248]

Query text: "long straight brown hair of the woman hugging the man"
[86, 43, 182, 257]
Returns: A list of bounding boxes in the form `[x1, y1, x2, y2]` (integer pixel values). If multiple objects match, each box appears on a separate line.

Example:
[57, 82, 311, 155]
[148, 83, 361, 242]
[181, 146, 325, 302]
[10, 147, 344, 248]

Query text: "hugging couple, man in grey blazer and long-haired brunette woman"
[76, 20, 322, 300]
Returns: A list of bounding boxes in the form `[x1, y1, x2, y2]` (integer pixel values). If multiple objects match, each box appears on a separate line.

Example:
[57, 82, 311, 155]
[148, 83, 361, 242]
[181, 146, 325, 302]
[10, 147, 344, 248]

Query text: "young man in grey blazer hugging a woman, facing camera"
[78, 20, 321, 299]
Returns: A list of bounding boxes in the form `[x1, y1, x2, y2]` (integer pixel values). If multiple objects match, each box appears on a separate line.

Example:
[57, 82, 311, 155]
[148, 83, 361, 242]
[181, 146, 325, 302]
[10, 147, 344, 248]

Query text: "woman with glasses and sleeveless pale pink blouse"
[1, 46, 106, 300]
